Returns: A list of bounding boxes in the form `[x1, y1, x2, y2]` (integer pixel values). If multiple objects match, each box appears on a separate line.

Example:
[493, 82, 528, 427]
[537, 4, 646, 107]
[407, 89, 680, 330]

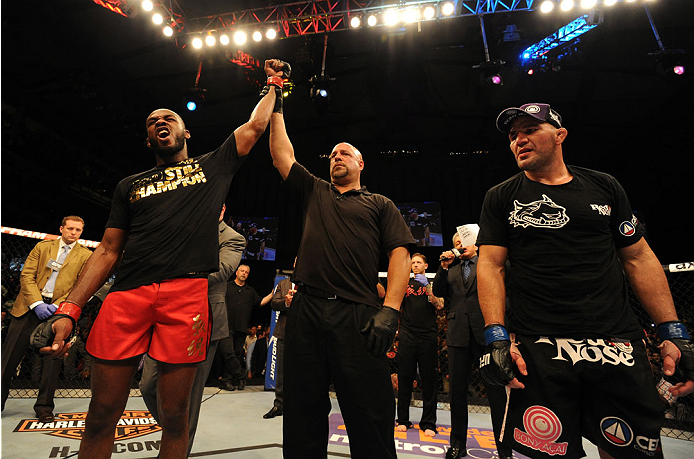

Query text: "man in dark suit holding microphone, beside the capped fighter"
[433, 233, 511, 459]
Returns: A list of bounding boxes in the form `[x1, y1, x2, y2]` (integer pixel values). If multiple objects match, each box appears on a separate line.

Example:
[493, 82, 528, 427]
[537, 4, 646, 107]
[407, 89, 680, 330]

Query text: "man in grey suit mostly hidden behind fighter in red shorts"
[140, 206, 246, 455]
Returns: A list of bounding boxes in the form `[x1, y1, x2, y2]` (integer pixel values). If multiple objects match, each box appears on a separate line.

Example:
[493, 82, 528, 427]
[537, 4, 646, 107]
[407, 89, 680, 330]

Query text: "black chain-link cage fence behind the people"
[0, 233, 694, 441]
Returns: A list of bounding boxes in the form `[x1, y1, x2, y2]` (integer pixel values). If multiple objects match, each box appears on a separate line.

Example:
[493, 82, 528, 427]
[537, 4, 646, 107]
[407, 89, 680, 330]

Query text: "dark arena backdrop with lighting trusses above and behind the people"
[0, 0, 694, 452]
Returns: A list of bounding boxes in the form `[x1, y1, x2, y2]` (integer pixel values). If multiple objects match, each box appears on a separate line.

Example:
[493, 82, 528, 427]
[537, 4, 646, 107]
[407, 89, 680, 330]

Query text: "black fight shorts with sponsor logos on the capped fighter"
[501, 335, 663, 459]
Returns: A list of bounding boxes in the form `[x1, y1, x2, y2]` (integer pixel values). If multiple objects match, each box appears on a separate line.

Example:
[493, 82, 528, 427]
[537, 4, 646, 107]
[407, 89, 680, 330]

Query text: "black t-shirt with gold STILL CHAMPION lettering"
[106, 134, 244, 292]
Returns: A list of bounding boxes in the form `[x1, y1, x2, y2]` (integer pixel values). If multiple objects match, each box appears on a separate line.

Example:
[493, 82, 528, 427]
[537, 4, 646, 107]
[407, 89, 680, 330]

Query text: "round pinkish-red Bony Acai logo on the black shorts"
[513, 405, 569, 456]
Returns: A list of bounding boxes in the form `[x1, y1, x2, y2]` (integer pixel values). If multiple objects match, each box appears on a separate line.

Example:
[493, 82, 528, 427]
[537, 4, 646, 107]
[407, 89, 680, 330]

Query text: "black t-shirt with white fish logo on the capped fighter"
[477, 166, 645, 339]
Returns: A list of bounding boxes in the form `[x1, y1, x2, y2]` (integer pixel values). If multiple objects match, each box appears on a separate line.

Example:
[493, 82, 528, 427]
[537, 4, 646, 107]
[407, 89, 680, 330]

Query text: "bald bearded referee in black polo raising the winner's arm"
[270, 110, 415, 459]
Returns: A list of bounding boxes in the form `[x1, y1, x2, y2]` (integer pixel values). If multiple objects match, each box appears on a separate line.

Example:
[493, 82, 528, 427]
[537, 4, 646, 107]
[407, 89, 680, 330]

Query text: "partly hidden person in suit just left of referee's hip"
[263, 274, 296, 419]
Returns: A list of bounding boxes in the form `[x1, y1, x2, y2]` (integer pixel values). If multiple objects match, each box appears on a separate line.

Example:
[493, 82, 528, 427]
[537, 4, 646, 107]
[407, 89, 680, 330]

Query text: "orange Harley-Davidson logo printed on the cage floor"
[14, 410, 161, 441]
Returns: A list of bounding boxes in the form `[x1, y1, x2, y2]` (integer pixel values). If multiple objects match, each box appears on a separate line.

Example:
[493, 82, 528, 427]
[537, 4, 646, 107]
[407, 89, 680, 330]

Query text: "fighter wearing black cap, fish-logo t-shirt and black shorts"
[477, 103, 694, 459]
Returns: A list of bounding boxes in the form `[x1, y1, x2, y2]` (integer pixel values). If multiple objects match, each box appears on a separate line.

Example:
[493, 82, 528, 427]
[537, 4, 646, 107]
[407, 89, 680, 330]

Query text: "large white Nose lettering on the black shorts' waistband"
[535, 336, 634, 367]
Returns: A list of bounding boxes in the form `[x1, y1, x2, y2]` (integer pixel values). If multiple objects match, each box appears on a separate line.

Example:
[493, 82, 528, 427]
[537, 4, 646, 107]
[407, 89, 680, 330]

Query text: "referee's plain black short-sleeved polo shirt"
[285, 163, 415, 307]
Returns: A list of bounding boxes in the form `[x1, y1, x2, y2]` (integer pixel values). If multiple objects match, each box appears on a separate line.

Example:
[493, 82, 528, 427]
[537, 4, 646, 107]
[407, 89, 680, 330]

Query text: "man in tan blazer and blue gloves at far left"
[2, 215, 92, 422]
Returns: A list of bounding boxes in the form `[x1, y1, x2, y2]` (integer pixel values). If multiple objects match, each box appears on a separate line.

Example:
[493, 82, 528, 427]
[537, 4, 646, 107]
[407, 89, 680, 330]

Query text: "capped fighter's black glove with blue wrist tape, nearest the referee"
[480, 324, 516, 386]
